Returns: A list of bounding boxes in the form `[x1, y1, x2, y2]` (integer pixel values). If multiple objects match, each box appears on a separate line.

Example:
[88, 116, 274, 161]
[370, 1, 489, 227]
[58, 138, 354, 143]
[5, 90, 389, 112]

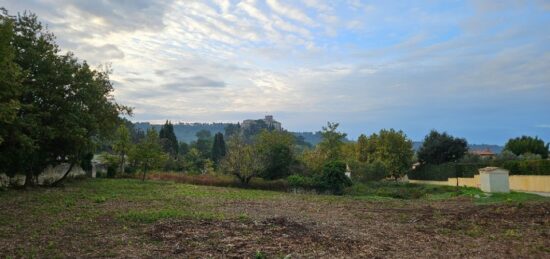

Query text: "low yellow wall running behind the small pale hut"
[409, 174, 550, 193]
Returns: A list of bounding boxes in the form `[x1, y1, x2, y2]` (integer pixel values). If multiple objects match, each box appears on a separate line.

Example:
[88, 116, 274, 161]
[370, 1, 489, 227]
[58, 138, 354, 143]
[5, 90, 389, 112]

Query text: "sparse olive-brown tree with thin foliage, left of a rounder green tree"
[222, 135, 262, 185]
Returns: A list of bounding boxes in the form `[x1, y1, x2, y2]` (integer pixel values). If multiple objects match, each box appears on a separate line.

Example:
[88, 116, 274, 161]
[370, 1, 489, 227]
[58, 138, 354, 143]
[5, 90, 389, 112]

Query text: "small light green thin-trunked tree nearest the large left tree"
[133, 128, 167, 181]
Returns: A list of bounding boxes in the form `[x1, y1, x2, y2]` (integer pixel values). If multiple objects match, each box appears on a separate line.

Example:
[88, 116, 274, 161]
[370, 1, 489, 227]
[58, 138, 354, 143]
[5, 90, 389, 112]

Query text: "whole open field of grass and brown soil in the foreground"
[0, 179, 550, 258]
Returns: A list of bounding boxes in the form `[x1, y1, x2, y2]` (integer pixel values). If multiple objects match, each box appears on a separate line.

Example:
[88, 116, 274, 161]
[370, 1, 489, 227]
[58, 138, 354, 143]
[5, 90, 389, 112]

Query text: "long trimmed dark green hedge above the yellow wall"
[408, 160, 550, 181]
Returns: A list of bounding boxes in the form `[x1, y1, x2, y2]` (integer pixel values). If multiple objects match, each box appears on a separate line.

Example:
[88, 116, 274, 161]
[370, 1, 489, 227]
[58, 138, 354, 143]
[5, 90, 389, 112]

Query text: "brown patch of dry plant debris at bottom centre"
[149, 217, 357, 258]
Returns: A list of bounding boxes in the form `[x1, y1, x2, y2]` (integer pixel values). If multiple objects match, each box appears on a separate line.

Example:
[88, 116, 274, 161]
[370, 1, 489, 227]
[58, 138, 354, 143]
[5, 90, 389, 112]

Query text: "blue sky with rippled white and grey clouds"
[0, 0, 550, 145]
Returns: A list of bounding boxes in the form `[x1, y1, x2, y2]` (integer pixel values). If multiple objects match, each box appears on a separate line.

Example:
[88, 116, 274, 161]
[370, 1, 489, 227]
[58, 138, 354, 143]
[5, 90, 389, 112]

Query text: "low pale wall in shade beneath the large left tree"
[0, 164, 86, 187]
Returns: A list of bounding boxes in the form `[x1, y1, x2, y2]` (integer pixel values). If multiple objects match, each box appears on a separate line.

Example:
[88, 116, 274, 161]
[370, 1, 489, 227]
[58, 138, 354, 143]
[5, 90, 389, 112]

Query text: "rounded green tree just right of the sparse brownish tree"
[256, 130, 294, 180]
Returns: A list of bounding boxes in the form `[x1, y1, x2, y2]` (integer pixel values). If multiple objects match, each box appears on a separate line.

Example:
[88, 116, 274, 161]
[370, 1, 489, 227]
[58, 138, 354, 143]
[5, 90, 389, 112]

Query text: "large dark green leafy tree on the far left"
[0, 11, 129, 185]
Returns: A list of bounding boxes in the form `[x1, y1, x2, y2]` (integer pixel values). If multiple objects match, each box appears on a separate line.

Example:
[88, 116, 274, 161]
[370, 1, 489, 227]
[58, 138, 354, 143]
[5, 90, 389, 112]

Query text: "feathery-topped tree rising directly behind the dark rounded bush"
[319, 122, 346, 160]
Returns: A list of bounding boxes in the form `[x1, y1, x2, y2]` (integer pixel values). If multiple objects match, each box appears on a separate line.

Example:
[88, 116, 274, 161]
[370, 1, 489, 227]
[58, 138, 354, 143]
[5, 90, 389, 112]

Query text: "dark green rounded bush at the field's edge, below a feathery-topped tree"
[320, 161, 352, 194]
